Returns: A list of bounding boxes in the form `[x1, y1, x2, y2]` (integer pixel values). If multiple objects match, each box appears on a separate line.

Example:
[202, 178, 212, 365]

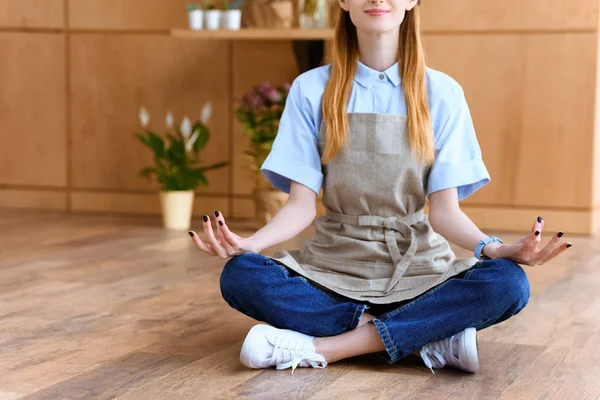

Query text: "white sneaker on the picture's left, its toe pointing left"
[240, 324, 327, 375]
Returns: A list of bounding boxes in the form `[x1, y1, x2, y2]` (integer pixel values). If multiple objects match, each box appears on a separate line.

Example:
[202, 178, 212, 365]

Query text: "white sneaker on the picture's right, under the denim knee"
[420, 328, 479, 374]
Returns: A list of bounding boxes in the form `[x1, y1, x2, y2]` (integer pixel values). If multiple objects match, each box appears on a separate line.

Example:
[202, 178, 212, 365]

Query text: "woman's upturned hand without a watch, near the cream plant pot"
[189, 210, 260, 258]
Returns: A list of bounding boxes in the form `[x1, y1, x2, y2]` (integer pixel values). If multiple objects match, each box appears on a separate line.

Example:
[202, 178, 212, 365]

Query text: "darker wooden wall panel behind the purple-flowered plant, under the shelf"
[233, 41, 298, 194]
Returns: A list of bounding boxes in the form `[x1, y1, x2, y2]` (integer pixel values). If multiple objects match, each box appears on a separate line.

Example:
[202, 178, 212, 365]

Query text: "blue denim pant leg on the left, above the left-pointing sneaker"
[220, 253, 367, 337]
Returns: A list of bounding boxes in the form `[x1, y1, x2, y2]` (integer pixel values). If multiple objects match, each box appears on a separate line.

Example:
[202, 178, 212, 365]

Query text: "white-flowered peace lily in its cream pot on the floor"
[136, 103, 229, 230]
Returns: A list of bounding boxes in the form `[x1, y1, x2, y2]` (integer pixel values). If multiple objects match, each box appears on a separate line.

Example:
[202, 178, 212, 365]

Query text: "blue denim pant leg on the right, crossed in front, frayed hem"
[369, 259, 529, 363]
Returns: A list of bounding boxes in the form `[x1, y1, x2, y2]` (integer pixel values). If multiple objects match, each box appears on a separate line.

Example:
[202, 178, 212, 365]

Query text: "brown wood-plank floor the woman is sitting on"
[0, 210, 600, 400]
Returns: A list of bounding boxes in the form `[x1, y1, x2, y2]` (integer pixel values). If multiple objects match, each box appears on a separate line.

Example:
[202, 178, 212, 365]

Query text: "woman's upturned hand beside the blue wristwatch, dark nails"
[484, 218, 572, 266]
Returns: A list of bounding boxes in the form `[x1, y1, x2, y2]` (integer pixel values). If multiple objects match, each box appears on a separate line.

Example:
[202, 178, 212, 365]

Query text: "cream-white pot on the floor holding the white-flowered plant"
[160, 190, 194, 231]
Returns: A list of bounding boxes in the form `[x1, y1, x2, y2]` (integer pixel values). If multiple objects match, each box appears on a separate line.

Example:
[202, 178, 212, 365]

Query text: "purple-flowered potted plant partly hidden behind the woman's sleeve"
[235, 82, 290, 225]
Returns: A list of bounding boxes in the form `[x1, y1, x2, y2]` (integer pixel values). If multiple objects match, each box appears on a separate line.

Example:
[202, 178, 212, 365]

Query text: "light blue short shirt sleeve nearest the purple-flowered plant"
[260, 79, 323, 194]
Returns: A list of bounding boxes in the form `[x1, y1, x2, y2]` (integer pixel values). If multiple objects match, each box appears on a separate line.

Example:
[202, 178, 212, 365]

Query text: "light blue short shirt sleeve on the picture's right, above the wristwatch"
[427, 84, 490, 201]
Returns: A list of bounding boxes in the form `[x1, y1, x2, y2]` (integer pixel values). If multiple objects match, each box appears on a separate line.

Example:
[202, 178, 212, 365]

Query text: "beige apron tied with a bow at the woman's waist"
[271, 113, 478, 304]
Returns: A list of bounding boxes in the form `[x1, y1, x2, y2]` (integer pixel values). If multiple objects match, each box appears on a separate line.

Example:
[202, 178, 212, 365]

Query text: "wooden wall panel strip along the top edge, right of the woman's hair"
[422, 0, 600, 31]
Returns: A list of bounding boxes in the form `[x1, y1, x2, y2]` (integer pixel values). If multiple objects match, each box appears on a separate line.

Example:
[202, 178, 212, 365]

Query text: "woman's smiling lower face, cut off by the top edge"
[338, 0, 418, 33]
